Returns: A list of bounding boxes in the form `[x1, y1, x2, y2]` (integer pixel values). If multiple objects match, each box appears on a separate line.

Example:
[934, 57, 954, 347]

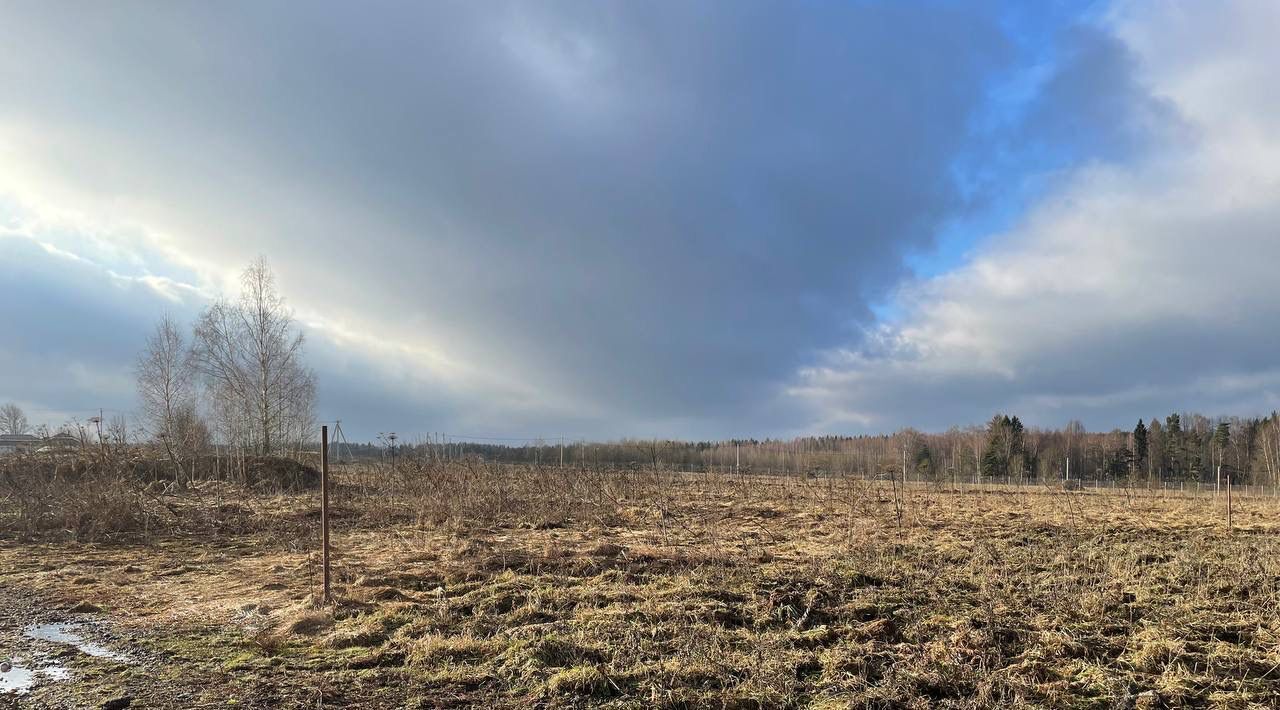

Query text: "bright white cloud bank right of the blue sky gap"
[790, 1, 1280, 429]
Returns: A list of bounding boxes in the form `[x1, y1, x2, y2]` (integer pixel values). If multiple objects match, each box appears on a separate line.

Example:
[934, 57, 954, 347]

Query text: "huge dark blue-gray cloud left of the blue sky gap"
[0, 3, 1029, 435]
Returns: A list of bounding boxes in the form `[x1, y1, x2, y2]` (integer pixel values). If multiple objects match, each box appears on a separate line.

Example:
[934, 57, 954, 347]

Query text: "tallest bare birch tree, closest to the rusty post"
[193, 258, 315, 453]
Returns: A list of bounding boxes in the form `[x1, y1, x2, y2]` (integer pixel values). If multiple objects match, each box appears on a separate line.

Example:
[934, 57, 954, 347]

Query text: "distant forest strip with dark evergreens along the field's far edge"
[333, 412, 1280, 485]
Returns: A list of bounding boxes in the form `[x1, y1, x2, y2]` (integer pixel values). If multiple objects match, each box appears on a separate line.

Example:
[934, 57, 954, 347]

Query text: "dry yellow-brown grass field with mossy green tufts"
[0, 463, 1280, 709]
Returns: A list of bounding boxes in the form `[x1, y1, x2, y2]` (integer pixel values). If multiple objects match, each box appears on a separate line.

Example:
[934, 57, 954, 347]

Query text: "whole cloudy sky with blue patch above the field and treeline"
[0, 0, 1280, 439]
